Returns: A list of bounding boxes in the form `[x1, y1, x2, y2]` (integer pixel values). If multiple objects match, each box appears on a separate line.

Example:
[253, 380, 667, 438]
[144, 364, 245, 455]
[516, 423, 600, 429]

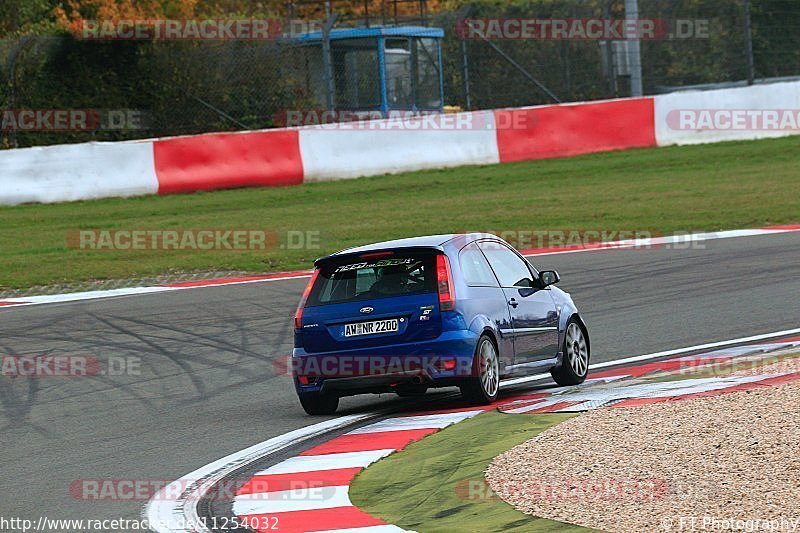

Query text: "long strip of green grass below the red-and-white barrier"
[0, 137, 800, 290]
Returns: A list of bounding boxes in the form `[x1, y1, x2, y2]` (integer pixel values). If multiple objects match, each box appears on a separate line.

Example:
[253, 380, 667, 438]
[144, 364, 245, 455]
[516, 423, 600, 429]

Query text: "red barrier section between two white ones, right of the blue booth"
[494, 98, 656, 163]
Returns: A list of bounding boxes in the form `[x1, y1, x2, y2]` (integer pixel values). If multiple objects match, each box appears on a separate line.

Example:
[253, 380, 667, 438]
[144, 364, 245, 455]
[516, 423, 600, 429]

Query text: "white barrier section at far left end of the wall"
[0, 141, 158, 205]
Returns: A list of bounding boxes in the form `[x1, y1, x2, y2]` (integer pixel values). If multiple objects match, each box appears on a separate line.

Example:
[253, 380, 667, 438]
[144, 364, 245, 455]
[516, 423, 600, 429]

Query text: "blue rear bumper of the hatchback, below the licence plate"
[291, 330, 478, 396]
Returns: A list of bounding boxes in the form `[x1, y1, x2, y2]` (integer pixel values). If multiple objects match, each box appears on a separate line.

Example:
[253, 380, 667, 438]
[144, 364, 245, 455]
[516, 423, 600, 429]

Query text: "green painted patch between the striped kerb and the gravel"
[350, 412, 589, 533]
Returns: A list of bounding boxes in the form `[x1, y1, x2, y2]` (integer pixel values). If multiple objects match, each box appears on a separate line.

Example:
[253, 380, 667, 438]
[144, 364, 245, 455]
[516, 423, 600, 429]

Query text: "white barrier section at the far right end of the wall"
[655, 82, 800, 146]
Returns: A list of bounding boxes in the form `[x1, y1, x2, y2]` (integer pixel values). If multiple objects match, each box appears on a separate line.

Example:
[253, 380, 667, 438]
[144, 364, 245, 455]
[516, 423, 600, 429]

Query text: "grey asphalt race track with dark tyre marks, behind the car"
[0, 233, 800, 519]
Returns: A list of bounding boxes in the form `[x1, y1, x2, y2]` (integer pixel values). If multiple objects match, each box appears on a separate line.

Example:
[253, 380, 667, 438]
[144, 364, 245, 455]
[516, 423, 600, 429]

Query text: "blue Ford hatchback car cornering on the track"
[292, 233, 589, 415]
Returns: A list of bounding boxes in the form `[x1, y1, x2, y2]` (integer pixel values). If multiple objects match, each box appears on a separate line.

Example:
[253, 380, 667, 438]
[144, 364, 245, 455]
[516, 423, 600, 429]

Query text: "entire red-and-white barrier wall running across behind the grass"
[0, 82, 800, 205]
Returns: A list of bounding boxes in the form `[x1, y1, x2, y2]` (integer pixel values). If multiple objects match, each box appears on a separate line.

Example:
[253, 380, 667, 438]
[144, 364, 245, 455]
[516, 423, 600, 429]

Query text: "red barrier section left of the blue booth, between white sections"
[153, 130, 303, 194]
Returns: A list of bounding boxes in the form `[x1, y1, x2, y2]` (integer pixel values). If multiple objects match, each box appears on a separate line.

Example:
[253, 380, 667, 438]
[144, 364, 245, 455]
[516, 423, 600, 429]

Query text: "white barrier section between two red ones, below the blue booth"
[299, 111, 500, 181]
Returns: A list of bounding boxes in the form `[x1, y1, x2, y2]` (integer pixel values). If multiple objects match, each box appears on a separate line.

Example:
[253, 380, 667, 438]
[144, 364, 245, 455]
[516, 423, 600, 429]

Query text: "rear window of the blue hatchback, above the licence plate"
[306, 254, 436, 307]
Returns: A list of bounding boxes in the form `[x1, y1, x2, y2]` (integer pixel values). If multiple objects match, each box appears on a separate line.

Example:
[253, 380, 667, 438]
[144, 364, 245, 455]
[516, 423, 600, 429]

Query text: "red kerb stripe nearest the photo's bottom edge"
[244, 506, 386, 533]
